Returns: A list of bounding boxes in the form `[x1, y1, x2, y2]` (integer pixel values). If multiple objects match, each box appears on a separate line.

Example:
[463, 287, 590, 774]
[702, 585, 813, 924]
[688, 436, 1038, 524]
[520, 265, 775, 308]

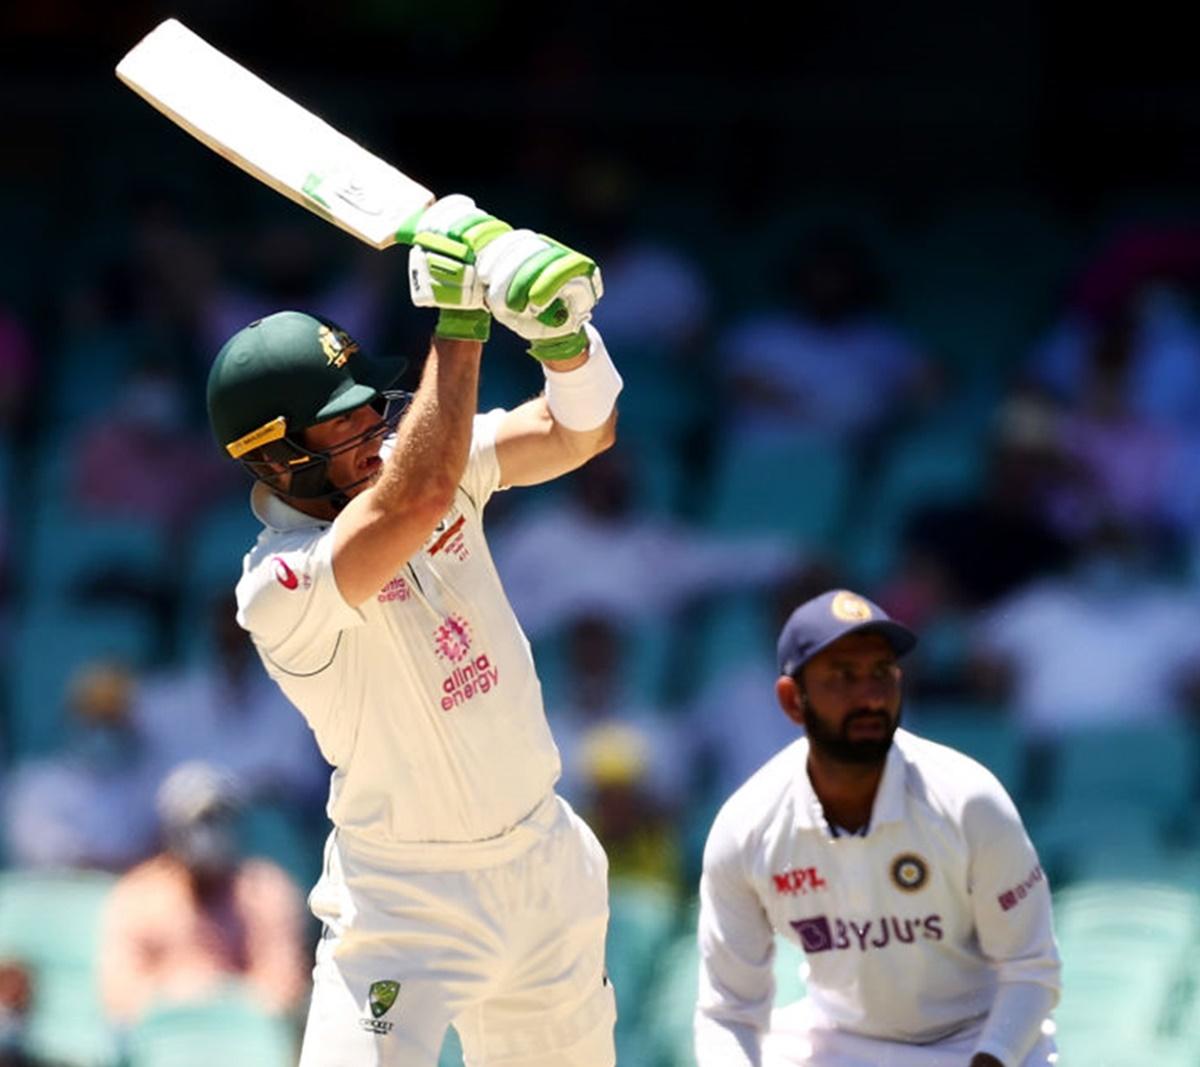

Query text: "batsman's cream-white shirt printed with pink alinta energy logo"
[238, 410, 559, 847]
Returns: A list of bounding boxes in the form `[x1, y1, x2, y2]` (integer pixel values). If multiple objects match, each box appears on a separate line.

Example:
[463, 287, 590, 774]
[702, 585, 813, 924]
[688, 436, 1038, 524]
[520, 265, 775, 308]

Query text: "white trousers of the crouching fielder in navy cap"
[762, 1000, 1055, 1067]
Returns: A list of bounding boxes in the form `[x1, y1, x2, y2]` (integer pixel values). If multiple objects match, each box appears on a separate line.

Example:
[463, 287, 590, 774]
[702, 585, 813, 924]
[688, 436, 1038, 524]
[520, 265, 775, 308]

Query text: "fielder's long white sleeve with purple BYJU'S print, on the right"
[962, 775, 1062, 1063]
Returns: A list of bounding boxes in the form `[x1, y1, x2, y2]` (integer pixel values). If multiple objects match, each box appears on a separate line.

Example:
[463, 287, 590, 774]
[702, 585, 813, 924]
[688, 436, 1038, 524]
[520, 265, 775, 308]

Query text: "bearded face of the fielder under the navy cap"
[776, 633, 901, 765]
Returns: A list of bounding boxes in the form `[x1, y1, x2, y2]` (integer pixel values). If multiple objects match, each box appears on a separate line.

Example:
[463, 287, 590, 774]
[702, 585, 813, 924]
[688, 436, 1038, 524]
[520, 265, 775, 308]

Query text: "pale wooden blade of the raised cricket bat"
[116, 18, 434, 248]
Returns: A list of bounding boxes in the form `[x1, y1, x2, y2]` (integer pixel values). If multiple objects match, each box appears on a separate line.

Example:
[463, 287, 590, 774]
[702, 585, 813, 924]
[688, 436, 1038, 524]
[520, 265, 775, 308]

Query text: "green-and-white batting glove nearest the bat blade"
[397, 193, 512, 341]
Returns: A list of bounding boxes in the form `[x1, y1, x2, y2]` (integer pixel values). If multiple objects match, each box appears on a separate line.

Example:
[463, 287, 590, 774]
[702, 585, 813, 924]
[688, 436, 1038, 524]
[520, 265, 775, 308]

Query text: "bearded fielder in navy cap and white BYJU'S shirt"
[695, 591, 1060, 1067]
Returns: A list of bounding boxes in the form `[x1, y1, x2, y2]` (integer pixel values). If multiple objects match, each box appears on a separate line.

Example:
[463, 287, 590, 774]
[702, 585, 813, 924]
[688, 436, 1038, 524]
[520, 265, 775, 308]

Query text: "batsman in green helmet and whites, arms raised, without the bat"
[208, 196, 622, 1067]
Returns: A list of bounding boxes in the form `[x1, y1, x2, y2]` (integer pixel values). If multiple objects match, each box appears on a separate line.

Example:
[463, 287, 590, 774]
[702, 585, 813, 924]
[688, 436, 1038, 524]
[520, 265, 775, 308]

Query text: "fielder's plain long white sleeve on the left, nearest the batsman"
[695, 816, 775, 1067]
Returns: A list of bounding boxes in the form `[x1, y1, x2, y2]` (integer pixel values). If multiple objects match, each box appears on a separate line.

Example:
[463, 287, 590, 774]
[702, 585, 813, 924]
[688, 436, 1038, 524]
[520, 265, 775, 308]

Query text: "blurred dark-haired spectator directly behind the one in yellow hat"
[551, 616, 691, 811]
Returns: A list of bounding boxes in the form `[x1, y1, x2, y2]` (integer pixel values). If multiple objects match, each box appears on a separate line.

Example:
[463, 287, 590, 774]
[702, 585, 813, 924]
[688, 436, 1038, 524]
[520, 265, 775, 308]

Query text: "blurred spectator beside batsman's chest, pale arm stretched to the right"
[493, 445, 796, 639]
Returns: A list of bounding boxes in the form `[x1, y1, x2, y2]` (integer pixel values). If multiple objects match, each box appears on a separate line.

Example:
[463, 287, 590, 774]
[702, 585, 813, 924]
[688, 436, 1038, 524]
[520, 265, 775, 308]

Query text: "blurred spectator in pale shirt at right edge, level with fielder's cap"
[973, 524, 1200, 736]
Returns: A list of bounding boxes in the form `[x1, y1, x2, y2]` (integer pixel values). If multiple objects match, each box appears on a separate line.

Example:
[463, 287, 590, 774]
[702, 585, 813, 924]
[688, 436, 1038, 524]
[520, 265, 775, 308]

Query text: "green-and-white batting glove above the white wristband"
[476, 229, 604, 362]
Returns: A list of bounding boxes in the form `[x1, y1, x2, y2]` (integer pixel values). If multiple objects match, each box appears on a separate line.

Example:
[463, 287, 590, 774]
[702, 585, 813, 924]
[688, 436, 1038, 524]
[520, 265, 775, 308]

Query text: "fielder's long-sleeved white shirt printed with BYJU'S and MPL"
[696, 730, 1060, 1067]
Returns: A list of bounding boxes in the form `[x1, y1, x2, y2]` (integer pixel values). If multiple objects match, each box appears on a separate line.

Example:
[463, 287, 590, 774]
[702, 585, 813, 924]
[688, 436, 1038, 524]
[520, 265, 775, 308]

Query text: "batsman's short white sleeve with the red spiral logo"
[238, 526, 365, 673]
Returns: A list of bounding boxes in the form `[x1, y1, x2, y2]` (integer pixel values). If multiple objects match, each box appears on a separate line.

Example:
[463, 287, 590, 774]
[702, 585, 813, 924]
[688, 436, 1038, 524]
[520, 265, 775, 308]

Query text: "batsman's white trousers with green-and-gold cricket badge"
[300, 796, 617, 1067]
